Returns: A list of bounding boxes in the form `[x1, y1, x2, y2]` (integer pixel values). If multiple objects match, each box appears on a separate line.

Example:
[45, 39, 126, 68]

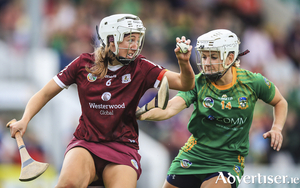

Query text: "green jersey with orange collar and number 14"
[168, 67, 275, 182]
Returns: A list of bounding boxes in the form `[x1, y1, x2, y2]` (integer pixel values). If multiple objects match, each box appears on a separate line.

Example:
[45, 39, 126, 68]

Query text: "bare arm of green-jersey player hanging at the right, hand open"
[263, 87, 288, 151]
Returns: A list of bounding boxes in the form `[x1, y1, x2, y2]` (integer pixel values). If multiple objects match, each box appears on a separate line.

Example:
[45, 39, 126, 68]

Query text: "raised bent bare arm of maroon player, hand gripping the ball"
[165, 36, 195, 91]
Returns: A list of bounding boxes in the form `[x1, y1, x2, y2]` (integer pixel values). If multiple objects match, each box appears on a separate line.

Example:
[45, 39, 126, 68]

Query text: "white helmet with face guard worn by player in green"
[195, 29, 240, 81]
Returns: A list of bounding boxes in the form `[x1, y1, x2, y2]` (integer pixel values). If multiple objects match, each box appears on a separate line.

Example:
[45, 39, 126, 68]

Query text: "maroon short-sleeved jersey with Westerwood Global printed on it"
[53, 53, 166, 149]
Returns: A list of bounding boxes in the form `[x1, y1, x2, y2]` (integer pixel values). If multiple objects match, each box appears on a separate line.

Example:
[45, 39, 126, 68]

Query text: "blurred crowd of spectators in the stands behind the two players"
[0, 0, 300, 168]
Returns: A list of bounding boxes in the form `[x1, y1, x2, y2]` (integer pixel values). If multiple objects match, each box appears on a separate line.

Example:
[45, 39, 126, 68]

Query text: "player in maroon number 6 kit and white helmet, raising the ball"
[10, 14, 195, 188]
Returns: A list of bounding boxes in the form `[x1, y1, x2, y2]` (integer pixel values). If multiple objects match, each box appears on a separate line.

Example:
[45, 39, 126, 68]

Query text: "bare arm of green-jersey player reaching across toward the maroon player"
[139, 96, 187, 121]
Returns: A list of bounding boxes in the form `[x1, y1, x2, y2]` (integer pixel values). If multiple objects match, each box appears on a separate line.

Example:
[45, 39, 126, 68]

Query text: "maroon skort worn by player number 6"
[65, 137, 142, 186]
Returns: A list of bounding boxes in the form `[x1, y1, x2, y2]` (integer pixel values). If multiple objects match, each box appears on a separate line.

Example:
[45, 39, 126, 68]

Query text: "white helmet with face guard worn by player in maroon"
[98, 14, 146, 64]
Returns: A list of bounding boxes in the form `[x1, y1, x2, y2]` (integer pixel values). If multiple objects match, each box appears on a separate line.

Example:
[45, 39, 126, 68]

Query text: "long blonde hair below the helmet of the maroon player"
[85, 46, 116, 79]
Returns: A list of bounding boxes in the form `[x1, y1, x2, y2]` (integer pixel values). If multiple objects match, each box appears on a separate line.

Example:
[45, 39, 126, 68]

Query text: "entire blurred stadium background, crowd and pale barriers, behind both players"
[0, 0, 300, 188]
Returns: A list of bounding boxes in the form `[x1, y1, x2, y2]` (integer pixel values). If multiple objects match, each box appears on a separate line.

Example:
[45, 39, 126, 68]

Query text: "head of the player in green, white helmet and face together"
[195, 29, 240, 82]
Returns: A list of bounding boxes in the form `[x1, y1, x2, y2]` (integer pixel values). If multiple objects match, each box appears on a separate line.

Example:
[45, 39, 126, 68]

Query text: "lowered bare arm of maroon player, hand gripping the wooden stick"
[10, 79, 62, 138]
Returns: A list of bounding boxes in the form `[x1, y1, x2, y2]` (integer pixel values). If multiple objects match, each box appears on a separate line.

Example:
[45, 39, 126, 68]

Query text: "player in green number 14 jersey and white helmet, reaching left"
[139, 29, 287, 188]
